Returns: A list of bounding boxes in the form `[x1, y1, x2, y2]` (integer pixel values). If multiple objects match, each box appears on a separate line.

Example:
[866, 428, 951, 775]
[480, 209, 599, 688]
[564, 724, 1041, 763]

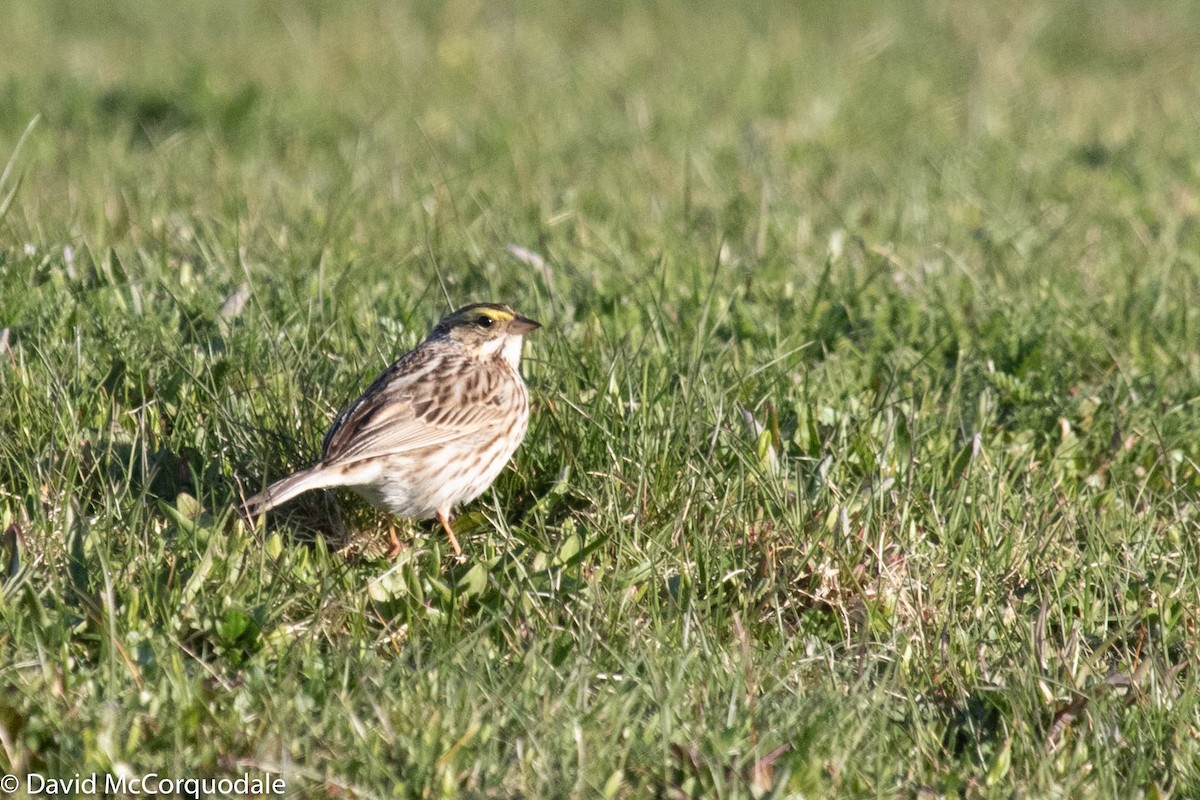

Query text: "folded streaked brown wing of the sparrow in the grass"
[323, 349, 518, 464]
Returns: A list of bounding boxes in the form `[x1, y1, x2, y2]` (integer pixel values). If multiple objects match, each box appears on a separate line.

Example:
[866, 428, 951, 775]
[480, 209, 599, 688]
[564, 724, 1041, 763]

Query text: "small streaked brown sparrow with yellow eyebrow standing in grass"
[244, 302, 541, 560]
